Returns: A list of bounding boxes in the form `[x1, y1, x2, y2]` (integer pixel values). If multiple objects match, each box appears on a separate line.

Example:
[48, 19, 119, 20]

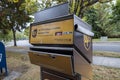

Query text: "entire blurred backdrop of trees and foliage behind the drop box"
[0, 0, 120, 45]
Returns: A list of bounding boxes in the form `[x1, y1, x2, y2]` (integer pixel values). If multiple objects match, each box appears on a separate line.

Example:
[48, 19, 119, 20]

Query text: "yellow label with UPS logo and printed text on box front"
[30, 19, 74, 44]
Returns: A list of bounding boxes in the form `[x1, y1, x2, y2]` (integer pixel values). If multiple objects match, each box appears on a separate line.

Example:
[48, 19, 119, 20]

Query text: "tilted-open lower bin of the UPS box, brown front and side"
[29, 48, 92, 80]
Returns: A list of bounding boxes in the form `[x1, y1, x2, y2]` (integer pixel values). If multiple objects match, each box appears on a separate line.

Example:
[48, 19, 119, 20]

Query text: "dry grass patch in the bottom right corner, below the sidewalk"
[93, 65, 120, 80]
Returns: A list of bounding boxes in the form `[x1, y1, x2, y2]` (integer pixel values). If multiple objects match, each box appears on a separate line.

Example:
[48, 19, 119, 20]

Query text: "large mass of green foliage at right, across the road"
[83, 2, 120, 38]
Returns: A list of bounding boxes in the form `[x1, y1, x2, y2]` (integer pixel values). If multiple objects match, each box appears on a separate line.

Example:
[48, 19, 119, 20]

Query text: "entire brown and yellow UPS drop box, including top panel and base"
[28, 3, 94, 80]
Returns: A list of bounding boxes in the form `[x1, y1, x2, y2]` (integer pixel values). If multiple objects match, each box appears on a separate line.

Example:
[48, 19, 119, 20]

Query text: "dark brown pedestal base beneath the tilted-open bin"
[41, 67, 81, 80]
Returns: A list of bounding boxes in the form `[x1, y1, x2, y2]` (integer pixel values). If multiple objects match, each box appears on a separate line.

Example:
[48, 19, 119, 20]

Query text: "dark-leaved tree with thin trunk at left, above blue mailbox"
[0, 0, 38, 46]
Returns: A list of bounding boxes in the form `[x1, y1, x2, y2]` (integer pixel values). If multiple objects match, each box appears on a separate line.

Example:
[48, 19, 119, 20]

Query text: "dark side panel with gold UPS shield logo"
[74, 31, 92, 63]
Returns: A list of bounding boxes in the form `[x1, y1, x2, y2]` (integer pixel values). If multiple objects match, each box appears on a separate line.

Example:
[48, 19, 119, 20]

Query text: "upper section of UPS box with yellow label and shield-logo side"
[29, 15, 94, 63]
